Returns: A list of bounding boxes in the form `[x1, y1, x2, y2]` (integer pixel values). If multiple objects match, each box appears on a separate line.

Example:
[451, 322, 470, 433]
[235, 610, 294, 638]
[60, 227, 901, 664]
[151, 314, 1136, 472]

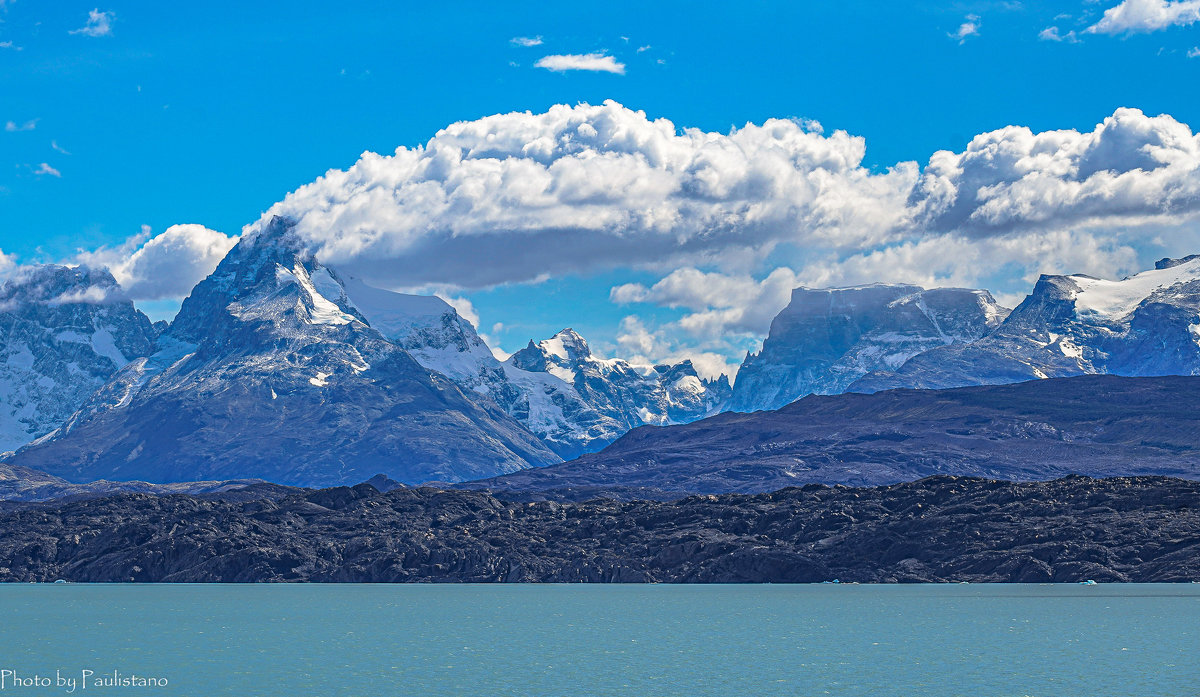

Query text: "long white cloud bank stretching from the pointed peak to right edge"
[247, 101, 1200, 289]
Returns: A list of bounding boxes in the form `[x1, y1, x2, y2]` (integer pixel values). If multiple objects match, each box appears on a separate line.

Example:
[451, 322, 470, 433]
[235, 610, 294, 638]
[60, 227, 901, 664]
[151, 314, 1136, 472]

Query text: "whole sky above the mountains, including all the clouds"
[0, 0, 1200, 373]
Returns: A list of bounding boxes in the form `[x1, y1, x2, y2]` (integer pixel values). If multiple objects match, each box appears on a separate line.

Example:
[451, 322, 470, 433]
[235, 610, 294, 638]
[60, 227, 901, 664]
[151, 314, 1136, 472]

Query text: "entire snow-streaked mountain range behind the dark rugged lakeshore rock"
[0, 218, 1200, 495]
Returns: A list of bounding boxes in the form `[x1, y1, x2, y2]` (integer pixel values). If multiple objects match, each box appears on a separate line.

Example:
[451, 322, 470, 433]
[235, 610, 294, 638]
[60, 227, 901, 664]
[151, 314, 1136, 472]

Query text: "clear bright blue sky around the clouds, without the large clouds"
[0, 0, 1200, 374]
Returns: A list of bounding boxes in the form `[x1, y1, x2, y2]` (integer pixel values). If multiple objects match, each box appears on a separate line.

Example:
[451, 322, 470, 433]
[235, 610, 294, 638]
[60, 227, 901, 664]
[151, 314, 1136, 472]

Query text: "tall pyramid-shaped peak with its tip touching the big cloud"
[8, 220, 559, 486]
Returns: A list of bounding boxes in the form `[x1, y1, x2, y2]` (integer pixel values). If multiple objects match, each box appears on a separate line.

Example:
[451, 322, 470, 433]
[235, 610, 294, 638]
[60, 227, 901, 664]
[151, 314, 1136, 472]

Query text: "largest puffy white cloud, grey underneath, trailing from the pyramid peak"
[248, 101, 917, 288]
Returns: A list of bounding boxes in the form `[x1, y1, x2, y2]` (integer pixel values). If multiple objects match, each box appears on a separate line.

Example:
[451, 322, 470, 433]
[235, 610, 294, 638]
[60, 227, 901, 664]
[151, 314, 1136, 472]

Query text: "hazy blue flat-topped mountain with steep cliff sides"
[728, 284, 1008, 411]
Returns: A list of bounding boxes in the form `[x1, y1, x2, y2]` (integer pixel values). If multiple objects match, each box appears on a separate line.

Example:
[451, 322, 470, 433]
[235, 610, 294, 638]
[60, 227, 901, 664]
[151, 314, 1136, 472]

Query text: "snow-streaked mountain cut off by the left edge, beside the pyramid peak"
[0, 265, 156, 452]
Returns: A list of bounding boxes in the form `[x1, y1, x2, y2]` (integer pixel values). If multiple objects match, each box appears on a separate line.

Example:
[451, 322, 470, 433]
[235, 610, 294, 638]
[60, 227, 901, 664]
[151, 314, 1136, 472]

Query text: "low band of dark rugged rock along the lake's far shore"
[0, 476, 1200, 583]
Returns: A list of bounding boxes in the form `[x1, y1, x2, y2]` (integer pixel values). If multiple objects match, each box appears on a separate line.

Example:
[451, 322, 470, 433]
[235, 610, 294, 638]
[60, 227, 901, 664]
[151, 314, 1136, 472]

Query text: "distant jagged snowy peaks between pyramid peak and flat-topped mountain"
[505, 329, 730, 438]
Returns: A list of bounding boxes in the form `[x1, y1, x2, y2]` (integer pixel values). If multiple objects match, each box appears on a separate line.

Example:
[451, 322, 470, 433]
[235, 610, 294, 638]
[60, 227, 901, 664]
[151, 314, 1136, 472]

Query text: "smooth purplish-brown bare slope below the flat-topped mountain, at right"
[460, 375, 1200, 499]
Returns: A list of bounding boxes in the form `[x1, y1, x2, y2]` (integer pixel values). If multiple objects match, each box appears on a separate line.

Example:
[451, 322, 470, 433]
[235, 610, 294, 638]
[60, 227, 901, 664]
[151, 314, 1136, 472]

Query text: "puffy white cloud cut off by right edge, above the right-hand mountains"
[910, 109, 1200, 236]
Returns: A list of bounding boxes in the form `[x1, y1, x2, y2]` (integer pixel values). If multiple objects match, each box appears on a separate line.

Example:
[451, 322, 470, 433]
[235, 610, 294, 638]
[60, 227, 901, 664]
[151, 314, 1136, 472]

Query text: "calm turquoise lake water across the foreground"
[0, 584, 1200, 697]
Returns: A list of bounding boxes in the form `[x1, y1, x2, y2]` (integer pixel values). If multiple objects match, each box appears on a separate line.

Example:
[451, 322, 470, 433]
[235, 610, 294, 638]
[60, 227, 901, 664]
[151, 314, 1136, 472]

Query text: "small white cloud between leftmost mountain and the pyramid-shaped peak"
[74, 224, 238, 300]
